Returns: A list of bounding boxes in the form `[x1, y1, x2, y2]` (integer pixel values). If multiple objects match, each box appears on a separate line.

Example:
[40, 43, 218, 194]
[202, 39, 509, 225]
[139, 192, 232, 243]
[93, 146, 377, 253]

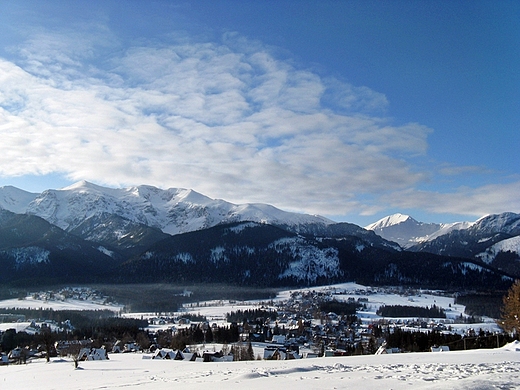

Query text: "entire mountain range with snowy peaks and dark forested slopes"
[0, 181, 520, 288]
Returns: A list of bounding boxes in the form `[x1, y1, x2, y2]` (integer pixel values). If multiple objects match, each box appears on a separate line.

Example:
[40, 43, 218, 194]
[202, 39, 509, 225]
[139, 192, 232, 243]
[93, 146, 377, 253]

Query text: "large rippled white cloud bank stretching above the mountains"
[0, 24, 519, 219]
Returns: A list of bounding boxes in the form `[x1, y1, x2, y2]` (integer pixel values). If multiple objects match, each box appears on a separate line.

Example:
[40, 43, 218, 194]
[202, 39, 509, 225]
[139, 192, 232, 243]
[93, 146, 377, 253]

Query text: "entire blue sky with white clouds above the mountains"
[0, 0, 520, 226]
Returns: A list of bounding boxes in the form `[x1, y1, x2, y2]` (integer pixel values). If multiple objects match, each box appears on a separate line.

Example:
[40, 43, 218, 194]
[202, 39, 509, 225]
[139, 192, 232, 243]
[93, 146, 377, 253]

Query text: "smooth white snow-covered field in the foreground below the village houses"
[0, 342, 520, 390]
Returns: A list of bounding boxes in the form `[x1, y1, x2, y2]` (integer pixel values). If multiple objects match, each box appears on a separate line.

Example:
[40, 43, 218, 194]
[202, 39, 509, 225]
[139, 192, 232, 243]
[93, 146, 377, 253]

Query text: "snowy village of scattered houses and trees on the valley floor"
[0, 283, 508, 364]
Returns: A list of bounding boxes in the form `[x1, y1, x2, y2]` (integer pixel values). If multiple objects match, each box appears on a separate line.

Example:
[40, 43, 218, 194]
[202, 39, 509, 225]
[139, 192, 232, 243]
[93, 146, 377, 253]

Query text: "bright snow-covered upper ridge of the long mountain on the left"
[0, 181, 334, 234]
